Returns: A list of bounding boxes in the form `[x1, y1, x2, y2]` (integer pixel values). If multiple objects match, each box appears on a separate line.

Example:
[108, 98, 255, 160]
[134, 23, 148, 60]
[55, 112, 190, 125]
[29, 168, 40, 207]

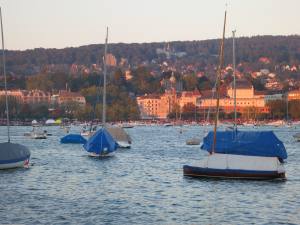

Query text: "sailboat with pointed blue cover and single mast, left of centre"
[83, 27, 119, 157]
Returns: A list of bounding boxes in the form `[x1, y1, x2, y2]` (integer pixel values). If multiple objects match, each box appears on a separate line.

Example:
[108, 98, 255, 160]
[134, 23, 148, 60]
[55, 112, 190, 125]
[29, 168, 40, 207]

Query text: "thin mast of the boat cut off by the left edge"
[0, 7, 10, 142]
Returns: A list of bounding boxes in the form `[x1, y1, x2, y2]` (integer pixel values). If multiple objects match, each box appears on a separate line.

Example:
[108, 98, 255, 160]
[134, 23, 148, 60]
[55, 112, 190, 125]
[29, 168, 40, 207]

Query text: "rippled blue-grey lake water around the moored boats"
[0, 126, 300, 224]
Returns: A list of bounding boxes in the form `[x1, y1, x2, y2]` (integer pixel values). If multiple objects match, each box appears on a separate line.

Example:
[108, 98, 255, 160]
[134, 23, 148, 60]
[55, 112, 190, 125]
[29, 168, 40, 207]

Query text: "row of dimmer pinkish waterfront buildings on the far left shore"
[0, 89, 86, 106]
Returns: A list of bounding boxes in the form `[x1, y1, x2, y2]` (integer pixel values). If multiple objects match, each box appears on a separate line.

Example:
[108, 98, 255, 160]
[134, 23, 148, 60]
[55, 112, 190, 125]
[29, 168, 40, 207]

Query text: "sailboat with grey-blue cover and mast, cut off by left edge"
[0, 7, 30, 169]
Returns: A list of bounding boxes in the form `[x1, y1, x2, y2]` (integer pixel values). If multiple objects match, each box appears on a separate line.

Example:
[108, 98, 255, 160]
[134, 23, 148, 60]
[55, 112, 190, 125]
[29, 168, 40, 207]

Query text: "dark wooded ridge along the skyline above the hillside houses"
[1, 35, 300, 75]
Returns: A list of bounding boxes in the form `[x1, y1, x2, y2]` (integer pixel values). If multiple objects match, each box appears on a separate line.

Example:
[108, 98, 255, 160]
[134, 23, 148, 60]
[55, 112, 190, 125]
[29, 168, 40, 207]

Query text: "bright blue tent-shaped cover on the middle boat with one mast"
[83, 128, 119, 154]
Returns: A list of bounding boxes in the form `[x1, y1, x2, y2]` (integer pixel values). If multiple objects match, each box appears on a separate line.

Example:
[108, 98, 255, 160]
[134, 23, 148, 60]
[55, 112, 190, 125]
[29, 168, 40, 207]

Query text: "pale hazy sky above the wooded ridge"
[0, 0, 300, 49]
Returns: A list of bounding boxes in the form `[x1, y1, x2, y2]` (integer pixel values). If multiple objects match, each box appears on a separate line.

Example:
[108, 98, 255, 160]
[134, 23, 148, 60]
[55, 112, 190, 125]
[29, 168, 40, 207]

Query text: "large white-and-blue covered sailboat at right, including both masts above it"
[183, 11, 287, 180]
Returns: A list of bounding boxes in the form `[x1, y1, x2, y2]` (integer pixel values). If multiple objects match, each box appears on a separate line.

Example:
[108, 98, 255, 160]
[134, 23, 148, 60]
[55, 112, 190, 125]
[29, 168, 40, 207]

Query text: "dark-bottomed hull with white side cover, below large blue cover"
[183, 153, 285, 180]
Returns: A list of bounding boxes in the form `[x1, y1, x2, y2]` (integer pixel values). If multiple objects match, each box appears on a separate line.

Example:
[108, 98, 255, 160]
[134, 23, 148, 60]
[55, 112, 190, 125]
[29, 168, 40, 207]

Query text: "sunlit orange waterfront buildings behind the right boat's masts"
[137, 80, 300, 119]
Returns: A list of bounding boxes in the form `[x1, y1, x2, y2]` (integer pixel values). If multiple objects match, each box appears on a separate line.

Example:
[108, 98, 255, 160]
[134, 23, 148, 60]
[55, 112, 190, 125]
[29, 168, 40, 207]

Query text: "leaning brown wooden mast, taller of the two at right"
[211, 10, 227, 154]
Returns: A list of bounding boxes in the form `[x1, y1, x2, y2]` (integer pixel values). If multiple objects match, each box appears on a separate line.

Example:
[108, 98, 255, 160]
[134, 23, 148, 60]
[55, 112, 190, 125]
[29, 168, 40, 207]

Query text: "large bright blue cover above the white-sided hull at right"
[201, 131, 287, 159]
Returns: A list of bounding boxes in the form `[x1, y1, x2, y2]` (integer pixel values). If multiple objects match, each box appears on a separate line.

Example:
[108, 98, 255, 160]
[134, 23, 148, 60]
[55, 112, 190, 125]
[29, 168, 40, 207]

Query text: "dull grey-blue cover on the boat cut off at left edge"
[0, 142, 30, 164]
